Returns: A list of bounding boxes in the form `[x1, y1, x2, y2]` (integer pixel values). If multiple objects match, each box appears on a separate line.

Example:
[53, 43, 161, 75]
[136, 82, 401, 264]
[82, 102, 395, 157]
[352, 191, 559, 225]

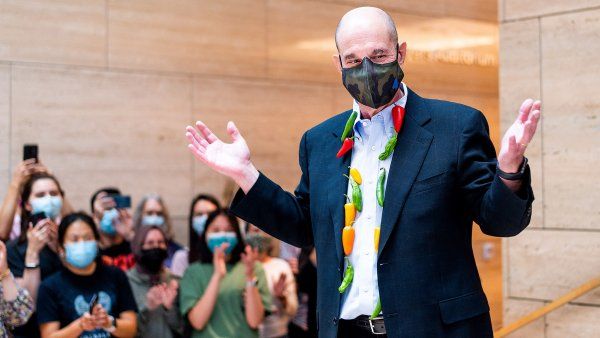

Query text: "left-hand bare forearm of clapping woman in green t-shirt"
[187, 243, 227, 331]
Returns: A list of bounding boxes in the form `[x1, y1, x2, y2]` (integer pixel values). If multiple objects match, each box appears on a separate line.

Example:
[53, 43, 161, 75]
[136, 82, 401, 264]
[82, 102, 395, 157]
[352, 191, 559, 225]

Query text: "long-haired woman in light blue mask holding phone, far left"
[7, 172, 64, 338]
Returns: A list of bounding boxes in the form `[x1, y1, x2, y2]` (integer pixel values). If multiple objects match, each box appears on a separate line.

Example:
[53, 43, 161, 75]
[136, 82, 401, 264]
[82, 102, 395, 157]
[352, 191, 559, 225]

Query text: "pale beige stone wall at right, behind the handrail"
[499, 0, 600, 337]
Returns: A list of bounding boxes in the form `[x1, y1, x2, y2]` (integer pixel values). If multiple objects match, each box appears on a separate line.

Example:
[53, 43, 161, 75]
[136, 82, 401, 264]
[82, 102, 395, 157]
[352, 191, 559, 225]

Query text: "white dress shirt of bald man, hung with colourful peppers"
[340, 83, 407, 319]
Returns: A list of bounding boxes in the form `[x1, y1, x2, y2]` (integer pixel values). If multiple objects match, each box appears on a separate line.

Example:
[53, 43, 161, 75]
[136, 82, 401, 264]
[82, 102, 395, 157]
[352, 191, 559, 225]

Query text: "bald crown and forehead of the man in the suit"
[335, 7, 398, 52]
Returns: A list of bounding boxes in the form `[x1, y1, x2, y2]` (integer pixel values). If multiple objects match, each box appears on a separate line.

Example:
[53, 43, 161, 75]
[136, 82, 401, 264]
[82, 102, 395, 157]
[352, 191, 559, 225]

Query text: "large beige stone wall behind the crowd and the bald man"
[0, 0, 502, 326]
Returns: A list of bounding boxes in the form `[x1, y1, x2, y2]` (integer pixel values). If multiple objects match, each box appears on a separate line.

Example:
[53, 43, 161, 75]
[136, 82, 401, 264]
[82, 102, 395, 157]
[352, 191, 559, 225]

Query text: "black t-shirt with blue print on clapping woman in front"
[37, 264, 137, 338]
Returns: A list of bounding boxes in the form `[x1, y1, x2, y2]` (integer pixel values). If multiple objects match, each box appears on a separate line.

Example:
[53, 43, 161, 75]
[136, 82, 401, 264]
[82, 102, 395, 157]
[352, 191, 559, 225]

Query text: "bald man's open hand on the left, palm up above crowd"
[185, 121, 258, 192]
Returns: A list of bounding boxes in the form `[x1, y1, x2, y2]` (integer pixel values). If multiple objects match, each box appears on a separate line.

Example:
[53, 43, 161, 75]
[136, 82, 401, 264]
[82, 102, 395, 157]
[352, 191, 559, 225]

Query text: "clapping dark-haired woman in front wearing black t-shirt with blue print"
[37, 213, 137, 338]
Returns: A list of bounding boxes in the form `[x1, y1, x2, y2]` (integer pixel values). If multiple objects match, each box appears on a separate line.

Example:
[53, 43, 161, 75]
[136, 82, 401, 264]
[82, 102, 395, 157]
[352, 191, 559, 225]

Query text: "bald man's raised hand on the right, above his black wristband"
[498, 99, 541, 173]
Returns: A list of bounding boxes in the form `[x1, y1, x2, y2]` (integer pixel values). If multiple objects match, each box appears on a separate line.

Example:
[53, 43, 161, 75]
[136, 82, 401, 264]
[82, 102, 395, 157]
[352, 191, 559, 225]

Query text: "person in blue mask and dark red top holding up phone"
[90, 188, 135, 271]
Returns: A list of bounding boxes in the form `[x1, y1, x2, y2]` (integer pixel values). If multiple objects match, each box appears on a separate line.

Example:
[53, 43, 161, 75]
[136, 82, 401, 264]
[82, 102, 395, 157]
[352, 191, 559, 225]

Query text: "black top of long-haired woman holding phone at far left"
[6, 241, 62, 338]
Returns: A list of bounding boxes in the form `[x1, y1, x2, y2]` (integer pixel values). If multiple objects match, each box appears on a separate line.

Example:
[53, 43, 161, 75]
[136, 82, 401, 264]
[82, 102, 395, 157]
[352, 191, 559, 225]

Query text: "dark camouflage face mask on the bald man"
[340, 46, 404, 108]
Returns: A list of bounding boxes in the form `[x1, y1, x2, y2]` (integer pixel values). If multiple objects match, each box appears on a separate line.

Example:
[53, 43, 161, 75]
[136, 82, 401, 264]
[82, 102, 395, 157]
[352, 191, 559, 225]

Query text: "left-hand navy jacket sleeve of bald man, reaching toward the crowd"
[231, 133, 313, 247]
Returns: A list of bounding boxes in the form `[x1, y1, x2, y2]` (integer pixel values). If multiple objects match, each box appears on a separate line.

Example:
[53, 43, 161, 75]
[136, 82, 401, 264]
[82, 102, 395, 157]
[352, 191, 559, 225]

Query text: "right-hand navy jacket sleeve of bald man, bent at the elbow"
[457, 111, 534, 237]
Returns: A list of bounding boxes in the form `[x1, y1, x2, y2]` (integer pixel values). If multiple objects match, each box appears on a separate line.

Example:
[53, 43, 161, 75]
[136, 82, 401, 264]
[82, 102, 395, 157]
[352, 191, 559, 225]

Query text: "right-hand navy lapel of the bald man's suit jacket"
[378, 89, 433, 255]
